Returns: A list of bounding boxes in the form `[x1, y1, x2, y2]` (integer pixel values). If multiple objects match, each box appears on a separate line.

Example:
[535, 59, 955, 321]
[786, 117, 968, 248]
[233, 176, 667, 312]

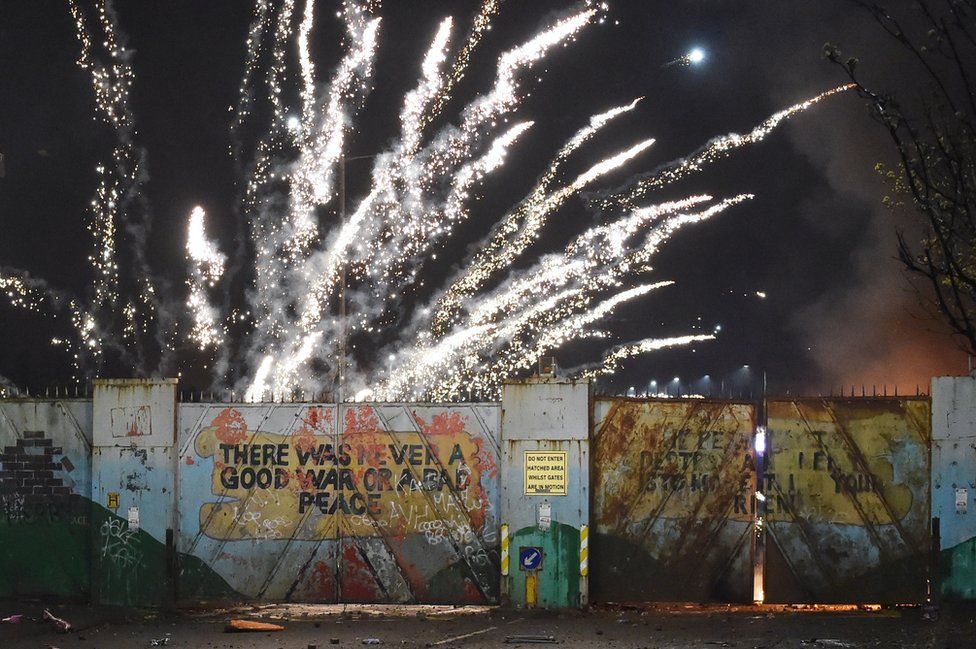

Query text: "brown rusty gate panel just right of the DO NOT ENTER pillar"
[591, 398, 755, 601]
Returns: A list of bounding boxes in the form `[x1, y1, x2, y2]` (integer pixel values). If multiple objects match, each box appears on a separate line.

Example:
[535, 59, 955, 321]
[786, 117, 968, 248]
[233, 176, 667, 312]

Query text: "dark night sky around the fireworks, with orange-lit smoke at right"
[0, 0, 966, 394]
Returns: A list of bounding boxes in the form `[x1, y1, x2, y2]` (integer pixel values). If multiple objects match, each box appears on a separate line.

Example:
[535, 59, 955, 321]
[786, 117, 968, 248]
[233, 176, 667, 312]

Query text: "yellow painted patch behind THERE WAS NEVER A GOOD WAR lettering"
[188, 408, 497, 541]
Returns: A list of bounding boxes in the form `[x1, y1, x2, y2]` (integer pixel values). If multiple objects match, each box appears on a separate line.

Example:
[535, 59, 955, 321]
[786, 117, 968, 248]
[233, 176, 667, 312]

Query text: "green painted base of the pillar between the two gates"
[508, 521, 580, 609]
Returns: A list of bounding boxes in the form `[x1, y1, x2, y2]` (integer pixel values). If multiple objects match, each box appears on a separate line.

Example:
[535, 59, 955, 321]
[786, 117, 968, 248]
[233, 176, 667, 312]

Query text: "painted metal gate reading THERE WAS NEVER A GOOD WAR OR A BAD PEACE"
[178, 404, 499, 604]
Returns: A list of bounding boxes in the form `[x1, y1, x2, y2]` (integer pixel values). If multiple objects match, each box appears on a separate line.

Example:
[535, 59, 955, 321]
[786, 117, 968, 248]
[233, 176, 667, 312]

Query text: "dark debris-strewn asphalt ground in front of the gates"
[0, 601, 976, 649]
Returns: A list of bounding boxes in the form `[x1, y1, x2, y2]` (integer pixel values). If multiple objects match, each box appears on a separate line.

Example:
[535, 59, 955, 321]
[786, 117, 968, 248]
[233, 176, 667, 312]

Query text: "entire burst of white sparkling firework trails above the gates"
[0, 0, 843, 401]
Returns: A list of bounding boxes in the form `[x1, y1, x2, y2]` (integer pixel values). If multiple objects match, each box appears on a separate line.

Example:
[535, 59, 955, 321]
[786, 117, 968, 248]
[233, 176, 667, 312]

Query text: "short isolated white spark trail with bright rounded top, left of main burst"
[186, 206, 227, 349]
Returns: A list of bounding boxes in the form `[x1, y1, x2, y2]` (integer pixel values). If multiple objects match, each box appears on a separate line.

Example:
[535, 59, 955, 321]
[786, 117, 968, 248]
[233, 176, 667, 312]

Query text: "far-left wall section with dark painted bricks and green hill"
[0, 399, 92, 600]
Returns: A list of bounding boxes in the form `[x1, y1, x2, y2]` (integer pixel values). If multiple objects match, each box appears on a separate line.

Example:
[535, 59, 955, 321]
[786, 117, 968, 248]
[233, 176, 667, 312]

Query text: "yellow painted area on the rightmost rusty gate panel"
[762, 399, 930, 525]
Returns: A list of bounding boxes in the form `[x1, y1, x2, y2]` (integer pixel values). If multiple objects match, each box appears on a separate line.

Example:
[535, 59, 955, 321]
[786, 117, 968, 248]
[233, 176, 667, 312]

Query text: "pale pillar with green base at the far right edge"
[932, 376, 976, 600]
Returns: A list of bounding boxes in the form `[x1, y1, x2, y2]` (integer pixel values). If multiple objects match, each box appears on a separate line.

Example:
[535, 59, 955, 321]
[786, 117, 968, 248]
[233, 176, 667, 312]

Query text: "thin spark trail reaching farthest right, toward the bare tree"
[600, 84, 854, 208]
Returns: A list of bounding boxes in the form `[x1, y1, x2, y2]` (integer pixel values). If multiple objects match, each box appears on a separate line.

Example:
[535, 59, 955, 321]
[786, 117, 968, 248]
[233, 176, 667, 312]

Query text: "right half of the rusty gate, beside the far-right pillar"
[760, 398, 931, 603]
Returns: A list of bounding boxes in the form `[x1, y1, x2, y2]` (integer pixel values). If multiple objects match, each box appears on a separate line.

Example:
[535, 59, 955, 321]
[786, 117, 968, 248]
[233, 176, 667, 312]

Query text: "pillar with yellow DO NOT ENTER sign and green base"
[501, 379, 590, 608]
